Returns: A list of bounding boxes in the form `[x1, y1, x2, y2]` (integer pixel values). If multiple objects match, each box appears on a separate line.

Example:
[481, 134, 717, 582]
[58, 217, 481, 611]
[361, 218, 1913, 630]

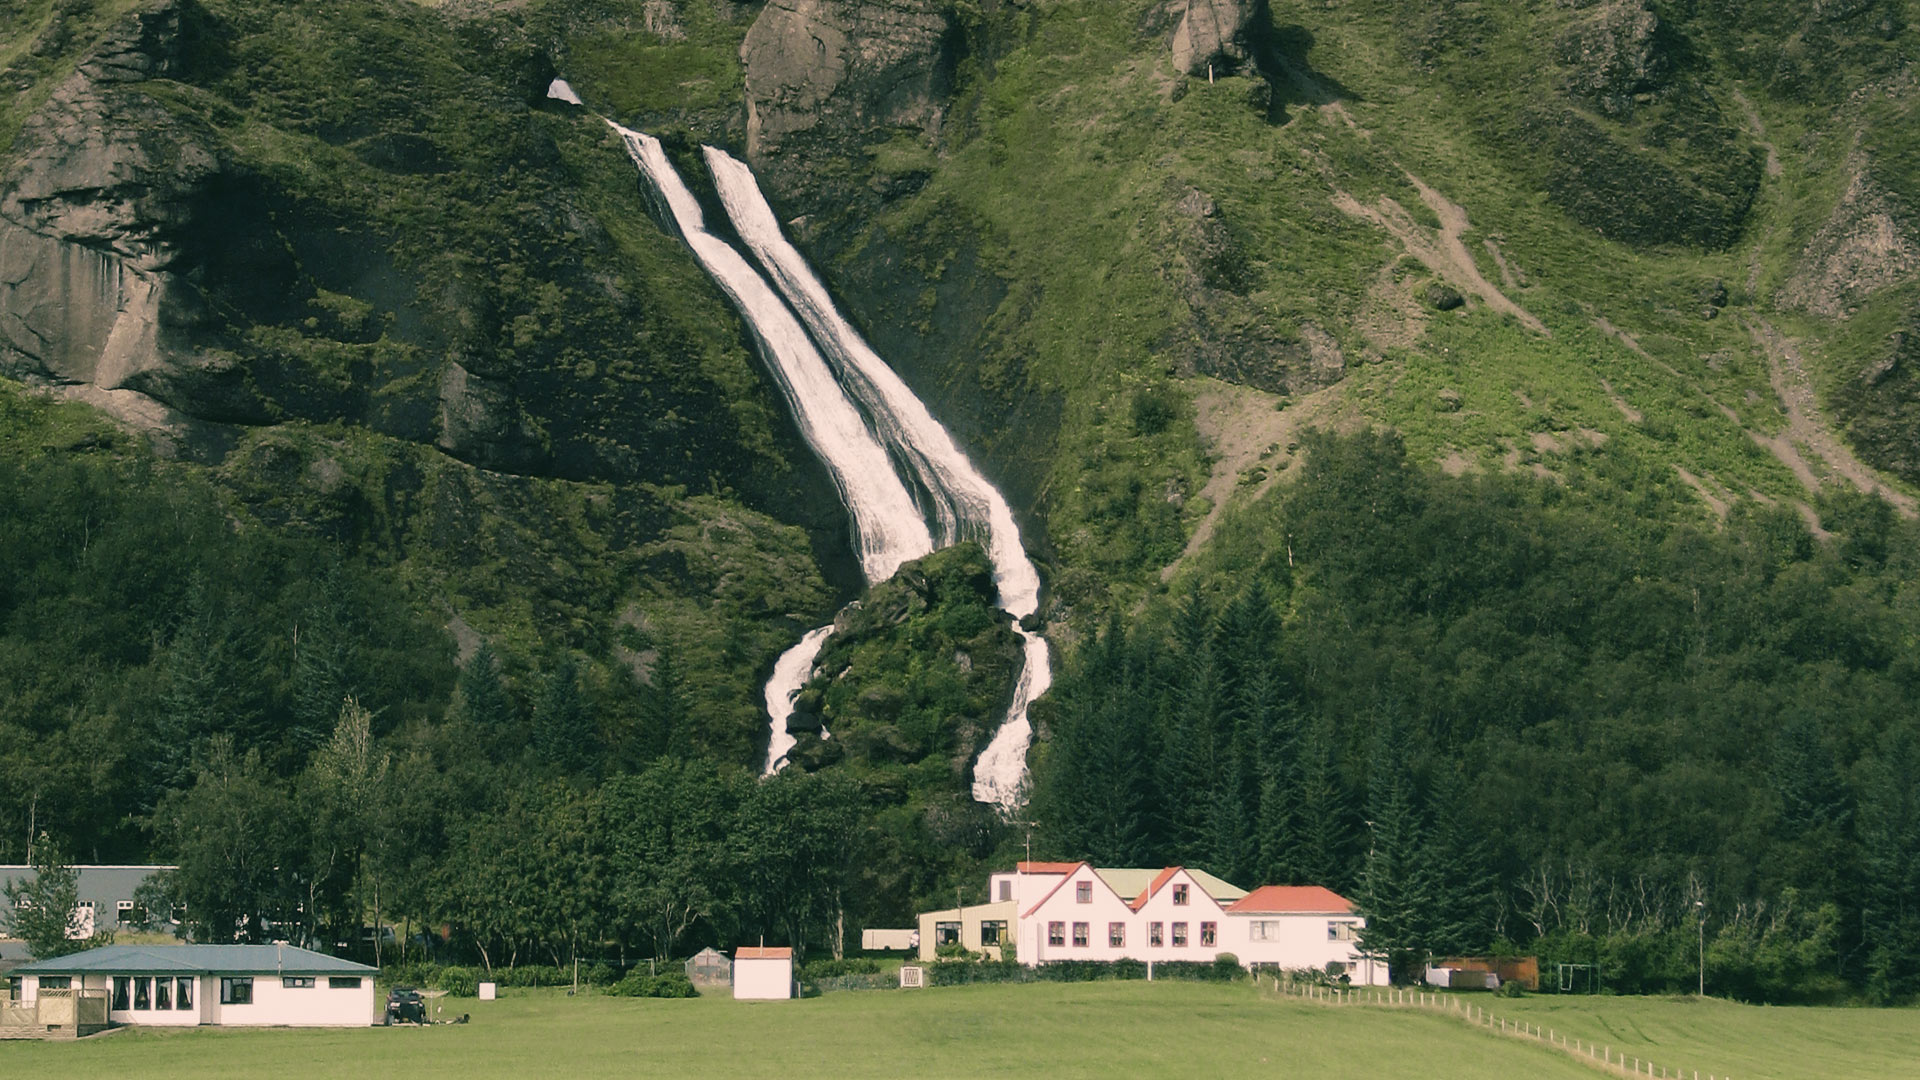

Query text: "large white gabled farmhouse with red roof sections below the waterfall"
[920, 863, 1386, 986]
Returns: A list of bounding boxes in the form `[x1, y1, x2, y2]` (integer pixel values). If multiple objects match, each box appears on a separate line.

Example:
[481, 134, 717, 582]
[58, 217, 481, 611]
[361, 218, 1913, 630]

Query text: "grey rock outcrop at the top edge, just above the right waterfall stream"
[741, 0, 960, 194]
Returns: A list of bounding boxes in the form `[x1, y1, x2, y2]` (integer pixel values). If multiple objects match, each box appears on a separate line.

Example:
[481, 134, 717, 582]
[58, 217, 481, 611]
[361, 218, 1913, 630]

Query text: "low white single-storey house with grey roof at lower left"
[12, 945, 378, 1028]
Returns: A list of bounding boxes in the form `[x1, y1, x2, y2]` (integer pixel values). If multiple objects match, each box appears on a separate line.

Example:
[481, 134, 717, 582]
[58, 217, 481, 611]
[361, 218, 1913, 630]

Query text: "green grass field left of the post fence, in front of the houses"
[8, 982, 1590, 1080]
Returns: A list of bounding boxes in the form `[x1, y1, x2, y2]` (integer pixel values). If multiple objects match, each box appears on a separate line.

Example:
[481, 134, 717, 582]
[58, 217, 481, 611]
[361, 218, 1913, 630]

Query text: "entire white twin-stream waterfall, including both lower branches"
[547, 79, 1052, 811]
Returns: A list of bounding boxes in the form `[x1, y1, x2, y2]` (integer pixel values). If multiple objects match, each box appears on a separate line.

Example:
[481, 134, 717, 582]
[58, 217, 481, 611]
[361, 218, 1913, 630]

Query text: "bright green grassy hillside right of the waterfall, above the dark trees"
[841, 0, 1920, 614]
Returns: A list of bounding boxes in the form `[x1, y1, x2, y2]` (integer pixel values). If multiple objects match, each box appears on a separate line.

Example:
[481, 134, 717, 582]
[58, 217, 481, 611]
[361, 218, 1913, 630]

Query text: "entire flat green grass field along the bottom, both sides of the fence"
[4, 982, 1920, 1080]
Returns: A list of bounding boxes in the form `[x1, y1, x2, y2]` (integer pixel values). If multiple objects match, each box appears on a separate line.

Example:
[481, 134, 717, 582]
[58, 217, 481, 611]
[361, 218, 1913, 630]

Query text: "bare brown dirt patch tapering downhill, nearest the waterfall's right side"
[1160, 379, 1344, 580]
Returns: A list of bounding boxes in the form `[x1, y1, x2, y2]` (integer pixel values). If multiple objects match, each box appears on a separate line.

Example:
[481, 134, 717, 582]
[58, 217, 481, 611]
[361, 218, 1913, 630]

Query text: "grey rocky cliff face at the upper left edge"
[0, 0, 253, 438]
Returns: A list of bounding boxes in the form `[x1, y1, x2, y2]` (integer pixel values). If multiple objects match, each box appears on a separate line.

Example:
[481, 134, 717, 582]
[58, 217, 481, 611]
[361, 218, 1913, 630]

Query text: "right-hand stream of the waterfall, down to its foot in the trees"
[703, 146, 1052, 807]
